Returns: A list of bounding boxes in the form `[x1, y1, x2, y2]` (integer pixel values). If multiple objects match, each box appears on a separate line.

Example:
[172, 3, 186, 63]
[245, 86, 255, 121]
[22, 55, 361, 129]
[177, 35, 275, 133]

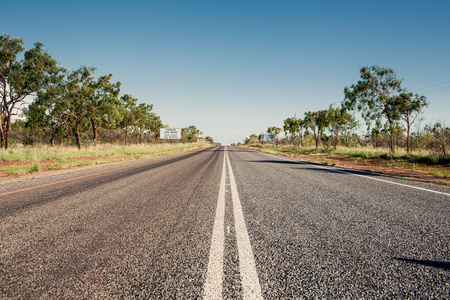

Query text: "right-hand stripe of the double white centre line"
[225, 151, 263, 299]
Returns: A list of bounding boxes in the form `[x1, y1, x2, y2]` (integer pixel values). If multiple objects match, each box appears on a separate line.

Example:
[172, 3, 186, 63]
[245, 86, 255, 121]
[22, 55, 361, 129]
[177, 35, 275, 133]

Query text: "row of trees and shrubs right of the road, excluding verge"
[244, 66, 450, 156]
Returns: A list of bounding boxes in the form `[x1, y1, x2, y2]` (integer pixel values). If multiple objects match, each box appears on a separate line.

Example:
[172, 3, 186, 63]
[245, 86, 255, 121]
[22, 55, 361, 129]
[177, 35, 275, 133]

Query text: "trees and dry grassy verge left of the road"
[0, 34, 218, 178]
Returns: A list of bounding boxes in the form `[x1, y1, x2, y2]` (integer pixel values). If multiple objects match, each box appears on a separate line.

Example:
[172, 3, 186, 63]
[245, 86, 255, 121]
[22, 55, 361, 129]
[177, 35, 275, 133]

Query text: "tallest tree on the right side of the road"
[342, 66, 402, 152]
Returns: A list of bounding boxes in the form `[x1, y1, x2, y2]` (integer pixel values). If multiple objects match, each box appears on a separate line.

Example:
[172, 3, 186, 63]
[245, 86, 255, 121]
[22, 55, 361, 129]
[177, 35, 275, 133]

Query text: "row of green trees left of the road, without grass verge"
[0, 34, 214, 149]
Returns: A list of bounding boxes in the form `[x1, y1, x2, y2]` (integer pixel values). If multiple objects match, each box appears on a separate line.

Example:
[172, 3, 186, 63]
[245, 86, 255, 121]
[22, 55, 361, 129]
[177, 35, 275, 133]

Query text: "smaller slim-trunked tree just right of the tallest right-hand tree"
[395, 91, 428, 153]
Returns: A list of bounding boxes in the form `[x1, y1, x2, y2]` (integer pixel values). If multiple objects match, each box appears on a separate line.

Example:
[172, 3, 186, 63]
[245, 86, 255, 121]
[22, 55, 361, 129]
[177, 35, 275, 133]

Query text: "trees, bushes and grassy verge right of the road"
[238, 66, 450, 183]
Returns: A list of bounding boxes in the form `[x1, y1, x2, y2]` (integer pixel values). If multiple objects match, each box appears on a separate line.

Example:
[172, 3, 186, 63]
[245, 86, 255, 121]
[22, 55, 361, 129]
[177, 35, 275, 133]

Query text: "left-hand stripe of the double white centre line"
[203, 150, 226, 299]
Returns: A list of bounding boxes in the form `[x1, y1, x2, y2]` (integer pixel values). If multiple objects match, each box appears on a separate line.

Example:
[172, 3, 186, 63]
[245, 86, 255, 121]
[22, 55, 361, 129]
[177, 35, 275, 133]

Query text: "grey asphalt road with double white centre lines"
[0, 147, 450, 299]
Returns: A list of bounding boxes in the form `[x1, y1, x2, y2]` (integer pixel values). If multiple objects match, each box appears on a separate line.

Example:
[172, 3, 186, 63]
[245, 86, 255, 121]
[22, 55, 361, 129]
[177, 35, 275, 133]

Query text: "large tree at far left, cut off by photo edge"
[0, 34, 60, 149]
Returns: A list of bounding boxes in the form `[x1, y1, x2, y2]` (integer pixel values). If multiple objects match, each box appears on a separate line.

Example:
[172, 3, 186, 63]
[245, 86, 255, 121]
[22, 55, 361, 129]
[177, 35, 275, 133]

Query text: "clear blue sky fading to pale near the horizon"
[0, 0, 450, 144]
